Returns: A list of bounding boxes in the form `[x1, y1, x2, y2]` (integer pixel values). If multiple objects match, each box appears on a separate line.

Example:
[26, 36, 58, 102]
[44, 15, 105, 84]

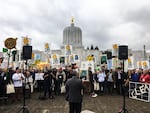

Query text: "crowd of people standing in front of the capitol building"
[0, 65, 150, 102]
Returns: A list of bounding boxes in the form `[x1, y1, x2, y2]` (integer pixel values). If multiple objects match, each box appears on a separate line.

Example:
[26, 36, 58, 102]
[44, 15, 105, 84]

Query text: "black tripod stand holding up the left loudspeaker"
[17, 60, 29, 113]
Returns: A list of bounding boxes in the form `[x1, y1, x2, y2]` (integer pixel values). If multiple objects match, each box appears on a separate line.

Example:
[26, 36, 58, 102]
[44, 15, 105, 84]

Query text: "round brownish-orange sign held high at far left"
[4, 38, 17, 49]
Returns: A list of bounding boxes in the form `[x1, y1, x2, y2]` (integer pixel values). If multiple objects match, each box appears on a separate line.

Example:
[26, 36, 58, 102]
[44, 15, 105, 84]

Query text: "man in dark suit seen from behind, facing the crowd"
[66, 71, 83, 113]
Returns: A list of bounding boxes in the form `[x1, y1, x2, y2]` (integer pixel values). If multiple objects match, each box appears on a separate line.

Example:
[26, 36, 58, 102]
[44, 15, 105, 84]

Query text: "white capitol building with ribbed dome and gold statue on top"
[1, 18, 150, 69]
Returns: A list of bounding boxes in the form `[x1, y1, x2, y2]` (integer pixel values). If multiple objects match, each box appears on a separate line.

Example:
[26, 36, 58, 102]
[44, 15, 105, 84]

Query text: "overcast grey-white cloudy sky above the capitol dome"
[0, 0, 150, 51]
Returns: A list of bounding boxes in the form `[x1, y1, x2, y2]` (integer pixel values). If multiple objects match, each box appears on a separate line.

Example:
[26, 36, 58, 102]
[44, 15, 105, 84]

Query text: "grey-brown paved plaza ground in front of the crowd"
[0, 93, 150, 113]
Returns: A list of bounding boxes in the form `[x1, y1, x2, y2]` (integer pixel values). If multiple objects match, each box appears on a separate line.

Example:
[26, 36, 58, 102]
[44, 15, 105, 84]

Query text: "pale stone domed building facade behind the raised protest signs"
[1, 19, 150, 68]
